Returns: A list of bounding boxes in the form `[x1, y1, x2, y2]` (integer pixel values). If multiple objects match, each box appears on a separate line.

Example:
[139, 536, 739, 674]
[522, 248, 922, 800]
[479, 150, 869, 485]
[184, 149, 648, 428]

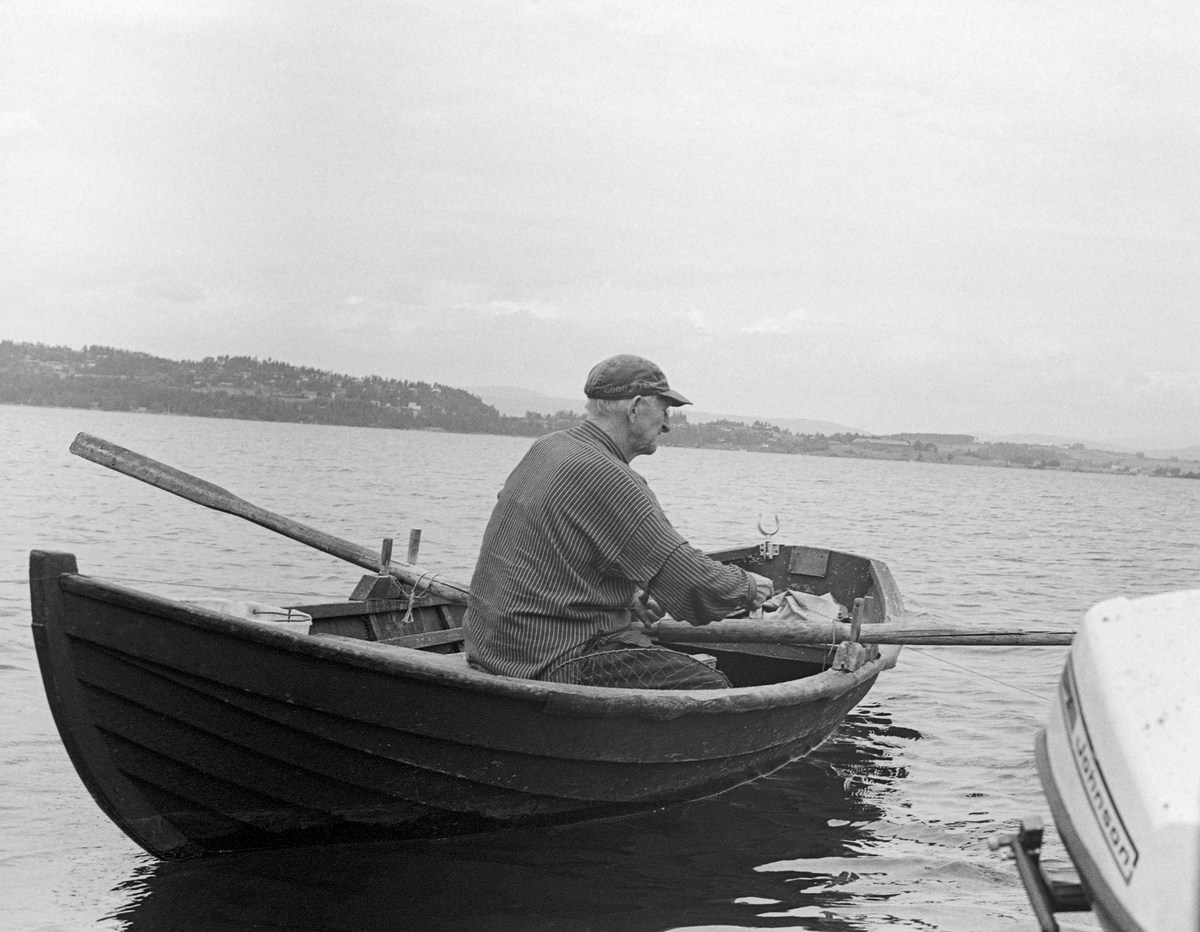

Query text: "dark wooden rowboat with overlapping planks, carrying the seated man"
[30, 545, 904, 859]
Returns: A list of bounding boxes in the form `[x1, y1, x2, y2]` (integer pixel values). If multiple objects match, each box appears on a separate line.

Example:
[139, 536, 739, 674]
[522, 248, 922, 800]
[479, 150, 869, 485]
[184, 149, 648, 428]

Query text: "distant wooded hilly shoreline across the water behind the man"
[7, 341, 1200, 479]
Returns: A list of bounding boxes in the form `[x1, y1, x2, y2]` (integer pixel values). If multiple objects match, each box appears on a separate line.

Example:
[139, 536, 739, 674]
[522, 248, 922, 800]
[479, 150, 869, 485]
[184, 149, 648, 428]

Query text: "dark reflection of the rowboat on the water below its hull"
[119, 704, 919, 932]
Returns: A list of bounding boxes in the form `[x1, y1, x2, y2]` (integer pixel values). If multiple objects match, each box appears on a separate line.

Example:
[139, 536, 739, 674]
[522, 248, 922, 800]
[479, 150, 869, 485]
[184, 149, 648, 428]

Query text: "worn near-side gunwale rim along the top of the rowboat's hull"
[46, 552, 900, 720]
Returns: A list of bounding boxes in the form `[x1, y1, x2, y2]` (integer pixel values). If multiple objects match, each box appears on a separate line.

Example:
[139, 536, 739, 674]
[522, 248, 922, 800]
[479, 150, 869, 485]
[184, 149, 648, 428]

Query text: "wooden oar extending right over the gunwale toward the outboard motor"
[652, 618, 1074, 647]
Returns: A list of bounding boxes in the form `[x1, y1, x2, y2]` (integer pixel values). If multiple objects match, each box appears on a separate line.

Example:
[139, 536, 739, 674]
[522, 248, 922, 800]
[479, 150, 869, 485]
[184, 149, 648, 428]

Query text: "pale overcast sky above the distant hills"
[0, 0, 1200, 445]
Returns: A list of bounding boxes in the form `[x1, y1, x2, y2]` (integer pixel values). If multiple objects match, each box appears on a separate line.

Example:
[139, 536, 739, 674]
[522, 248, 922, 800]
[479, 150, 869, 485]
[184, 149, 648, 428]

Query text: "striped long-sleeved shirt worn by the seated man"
[463, 421, 756, 685]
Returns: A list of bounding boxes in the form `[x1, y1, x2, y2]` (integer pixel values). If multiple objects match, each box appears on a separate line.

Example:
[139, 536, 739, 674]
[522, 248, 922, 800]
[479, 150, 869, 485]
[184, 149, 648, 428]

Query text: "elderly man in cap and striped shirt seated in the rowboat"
[463, 355, 772, 689]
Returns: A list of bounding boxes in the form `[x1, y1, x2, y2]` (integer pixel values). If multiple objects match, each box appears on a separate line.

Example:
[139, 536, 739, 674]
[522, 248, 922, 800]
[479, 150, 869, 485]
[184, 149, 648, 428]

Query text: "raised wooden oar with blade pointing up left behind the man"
[64, 433, 469, 602]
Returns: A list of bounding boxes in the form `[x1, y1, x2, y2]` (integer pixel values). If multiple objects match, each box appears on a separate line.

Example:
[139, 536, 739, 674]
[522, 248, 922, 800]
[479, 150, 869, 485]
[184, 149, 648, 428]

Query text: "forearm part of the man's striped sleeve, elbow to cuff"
[649, 543, 756, 625]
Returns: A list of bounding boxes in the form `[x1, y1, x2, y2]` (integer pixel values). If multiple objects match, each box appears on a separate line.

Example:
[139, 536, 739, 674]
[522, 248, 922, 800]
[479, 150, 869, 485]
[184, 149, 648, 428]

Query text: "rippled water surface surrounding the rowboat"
[0, 407, 1200, 932]
